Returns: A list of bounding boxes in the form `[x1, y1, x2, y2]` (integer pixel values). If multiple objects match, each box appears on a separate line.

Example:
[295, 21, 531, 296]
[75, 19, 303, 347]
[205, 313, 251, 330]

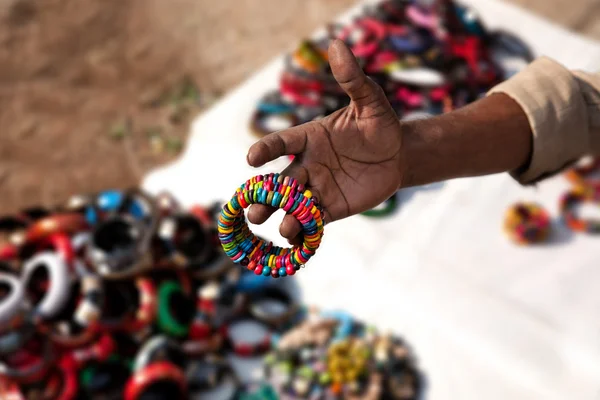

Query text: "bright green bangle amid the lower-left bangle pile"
[157, 281, 191, 337]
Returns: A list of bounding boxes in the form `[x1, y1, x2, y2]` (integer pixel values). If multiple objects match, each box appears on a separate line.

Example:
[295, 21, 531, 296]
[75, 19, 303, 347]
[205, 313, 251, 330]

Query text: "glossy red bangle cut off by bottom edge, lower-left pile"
[124, 361, 187, 400]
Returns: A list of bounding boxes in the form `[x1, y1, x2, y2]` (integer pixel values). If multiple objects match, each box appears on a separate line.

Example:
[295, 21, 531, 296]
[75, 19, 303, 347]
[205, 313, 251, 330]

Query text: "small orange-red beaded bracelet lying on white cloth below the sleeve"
[504, 203, 550, 245]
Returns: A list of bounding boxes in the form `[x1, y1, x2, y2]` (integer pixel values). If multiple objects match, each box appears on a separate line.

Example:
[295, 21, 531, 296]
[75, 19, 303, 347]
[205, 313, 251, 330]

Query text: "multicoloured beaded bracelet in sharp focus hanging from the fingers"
[218, 173, 324, 278]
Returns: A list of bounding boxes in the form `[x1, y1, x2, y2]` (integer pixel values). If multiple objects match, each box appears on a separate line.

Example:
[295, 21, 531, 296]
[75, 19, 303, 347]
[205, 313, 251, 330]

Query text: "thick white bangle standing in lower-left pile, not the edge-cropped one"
[23, 252, 71, 320]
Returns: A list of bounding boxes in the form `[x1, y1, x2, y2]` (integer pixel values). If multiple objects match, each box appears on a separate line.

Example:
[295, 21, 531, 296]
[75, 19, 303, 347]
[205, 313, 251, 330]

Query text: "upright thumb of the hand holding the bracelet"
[329, 39, 377, 105]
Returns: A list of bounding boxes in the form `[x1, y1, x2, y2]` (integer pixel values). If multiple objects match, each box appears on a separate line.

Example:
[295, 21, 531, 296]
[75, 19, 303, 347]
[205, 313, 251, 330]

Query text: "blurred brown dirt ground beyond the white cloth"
[0, 0, 600, 213]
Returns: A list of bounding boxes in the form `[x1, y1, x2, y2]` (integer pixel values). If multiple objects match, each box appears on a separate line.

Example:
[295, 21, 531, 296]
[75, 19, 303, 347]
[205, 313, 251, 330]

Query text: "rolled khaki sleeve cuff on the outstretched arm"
[489, 57, 600, 184]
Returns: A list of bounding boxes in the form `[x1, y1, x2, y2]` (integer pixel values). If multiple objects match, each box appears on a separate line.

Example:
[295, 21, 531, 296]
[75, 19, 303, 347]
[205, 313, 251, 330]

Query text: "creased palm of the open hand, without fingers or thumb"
[297, 98, 401, 220]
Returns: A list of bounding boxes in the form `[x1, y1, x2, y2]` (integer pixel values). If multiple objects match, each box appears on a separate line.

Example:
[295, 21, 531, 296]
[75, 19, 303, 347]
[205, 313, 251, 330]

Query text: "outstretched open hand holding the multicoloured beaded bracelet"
[247, 40, 403, 243]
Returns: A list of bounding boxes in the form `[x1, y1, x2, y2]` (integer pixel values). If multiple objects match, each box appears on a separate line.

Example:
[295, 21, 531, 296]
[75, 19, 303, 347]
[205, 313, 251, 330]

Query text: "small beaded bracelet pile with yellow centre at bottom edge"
[264, 312, 422, 400]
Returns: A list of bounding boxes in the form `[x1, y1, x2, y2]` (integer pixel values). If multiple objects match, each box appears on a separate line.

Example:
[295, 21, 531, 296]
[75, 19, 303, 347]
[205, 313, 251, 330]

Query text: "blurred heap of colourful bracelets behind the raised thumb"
[250, 0, 533, 217]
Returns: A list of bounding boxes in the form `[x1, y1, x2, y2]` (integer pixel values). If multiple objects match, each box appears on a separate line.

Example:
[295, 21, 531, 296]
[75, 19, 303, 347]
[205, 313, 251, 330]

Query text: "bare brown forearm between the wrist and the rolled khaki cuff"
[400, 94, 532, 187]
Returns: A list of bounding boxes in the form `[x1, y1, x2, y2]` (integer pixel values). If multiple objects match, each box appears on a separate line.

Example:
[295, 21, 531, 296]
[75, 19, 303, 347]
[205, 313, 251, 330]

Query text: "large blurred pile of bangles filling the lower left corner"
[0, 190, 422, 400]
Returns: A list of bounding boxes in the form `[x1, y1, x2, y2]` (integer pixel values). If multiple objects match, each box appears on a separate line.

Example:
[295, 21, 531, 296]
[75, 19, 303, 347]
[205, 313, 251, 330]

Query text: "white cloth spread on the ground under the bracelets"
[143, 0, 600, 400]
